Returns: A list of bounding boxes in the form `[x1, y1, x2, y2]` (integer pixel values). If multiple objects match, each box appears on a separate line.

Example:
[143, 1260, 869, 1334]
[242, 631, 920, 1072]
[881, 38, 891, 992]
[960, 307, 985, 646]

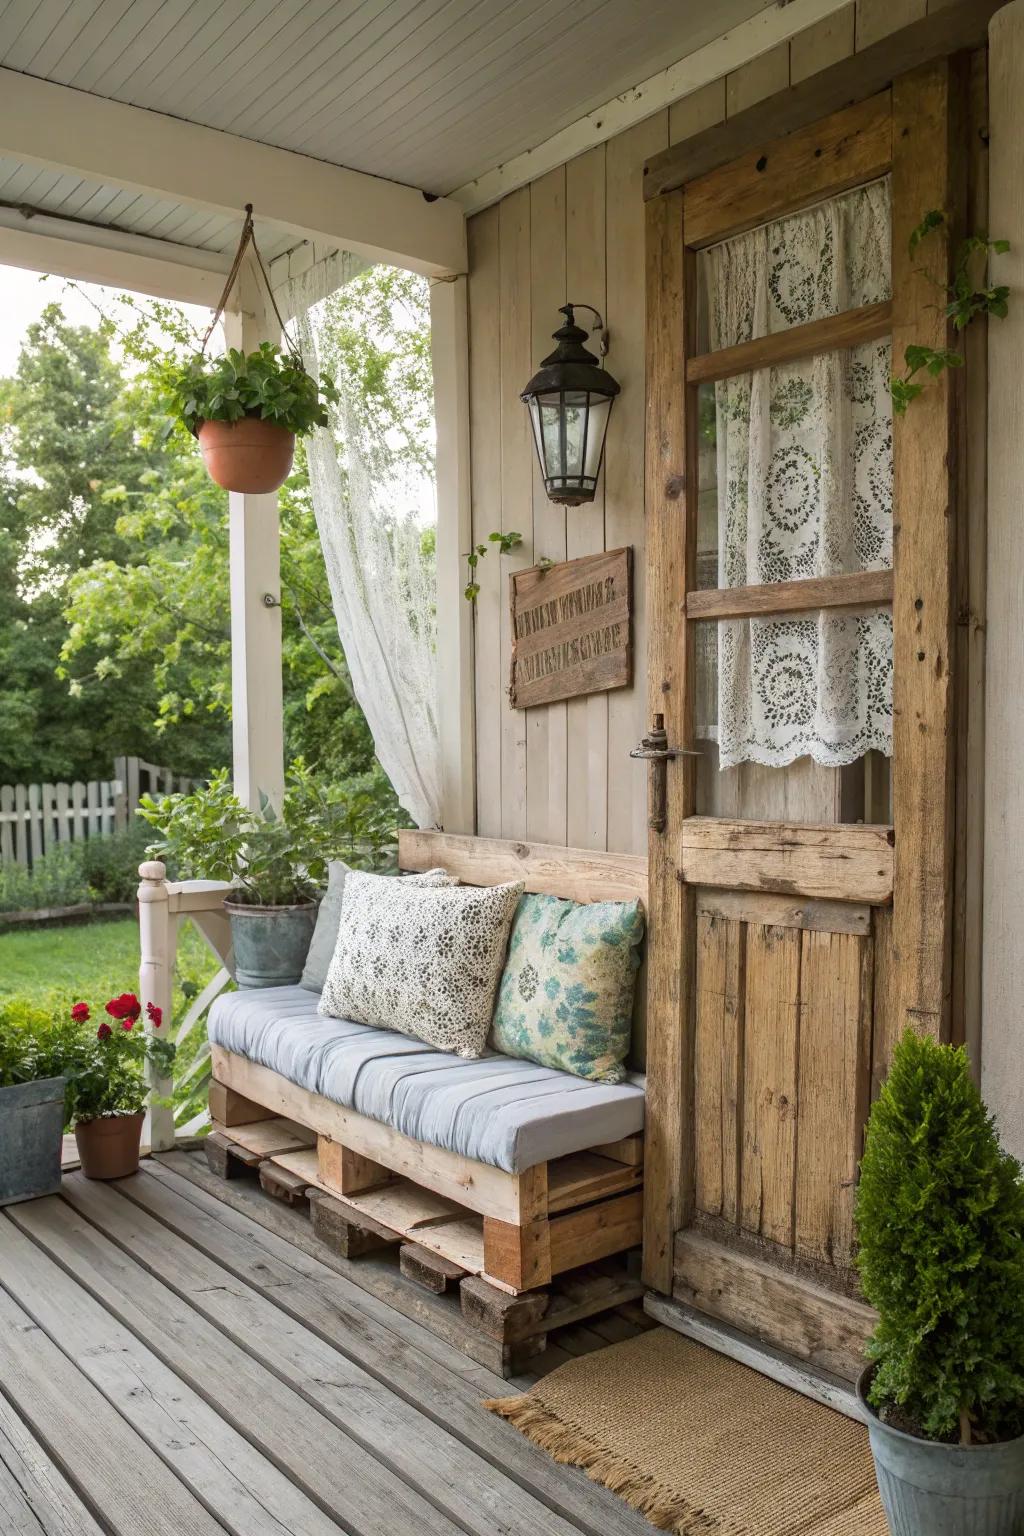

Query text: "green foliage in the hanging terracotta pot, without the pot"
[164, 341, 339, 438]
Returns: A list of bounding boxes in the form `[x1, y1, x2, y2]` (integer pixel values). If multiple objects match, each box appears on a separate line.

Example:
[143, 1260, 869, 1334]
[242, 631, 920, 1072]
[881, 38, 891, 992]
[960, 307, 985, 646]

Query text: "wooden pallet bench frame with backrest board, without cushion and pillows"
[207, 831, 646, 1376]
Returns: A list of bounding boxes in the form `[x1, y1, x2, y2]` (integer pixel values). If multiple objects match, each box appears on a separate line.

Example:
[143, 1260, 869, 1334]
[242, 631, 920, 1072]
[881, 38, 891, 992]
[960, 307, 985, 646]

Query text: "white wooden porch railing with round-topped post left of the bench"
[138, 860, 233, 1152]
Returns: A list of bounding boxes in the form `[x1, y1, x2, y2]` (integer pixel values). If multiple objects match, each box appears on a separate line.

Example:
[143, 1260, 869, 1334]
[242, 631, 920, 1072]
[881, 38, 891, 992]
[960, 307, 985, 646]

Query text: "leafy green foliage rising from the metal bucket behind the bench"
[138, 757, 395, 906]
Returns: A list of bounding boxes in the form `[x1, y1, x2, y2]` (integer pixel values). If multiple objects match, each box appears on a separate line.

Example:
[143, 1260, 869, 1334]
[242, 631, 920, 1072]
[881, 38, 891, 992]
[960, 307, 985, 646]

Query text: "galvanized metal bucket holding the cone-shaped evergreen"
[857, 1367, 1024, 1536]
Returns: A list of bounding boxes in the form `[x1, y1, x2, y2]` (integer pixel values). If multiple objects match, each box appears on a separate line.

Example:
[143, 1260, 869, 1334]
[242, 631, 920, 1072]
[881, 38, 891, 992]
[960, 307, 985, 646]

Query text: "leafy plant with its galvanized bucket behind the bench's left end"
[140, 762, 335, 986]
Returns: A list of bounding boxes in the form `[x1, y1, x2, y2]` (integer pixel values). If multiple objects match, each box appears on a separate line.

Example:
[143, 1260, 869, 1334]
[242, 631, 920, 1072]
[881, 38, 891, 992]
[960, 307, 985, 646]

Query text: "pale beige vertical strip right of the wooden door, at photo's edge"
[981, 0, 1024, 1157]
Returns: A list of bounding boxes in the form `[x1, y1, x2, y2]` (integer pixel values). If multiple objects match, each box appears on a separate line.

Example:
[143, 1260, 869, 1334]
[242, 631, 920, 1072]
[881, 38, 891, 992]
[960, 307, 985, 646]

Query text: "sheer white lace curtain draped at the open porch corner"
[289, 258, 441, 826]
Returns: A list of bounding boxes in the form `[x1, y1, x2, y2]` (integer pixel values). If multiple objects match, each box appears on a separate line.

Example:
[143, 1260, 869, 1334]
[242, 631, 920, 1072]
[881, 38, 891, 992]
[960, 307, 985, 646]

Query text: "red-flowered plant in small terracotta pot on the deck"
[71, 992, 175, 1178]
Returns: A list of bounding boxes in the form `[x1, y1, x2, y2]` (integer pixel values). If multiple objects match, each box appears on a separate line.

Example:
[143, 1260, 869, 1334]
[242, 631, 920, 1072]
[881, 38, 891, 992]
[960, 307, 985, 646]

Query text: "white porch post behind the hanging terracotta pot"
[224, 255, 284, 808]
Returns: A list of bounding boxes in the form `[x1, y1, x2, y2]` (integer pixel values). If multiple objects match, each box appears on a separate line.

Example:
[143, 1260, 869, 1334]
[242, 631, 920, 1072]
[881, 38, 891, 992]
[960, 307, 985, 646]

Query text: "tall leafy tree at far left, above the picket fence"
[0, 304, 178, 780]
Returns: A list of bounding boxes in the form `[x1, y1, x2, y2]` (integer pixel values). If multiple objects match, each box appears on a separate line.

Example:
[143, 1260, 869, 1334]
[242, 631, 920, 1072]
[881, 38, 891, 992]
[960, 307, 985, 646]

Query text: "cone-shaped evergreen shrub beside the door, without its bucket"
[857, 1031, 1024, 1445]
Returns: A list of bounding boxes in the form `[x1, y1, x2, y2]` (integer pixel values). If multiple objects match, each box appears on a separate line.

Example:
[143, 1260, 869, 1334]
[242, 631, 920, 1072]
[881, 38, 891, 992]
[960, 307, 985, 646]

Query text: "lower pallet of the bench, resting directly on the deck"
[204, 1118, 643, 1378]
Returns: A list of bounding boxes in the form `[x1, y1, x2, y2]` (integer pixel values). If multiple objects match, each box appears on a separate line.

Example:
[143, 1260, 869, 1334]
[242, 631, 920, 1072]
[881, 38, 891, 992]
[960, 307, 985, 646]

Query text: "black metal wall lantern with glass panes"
[520, 304, 619, 507]
